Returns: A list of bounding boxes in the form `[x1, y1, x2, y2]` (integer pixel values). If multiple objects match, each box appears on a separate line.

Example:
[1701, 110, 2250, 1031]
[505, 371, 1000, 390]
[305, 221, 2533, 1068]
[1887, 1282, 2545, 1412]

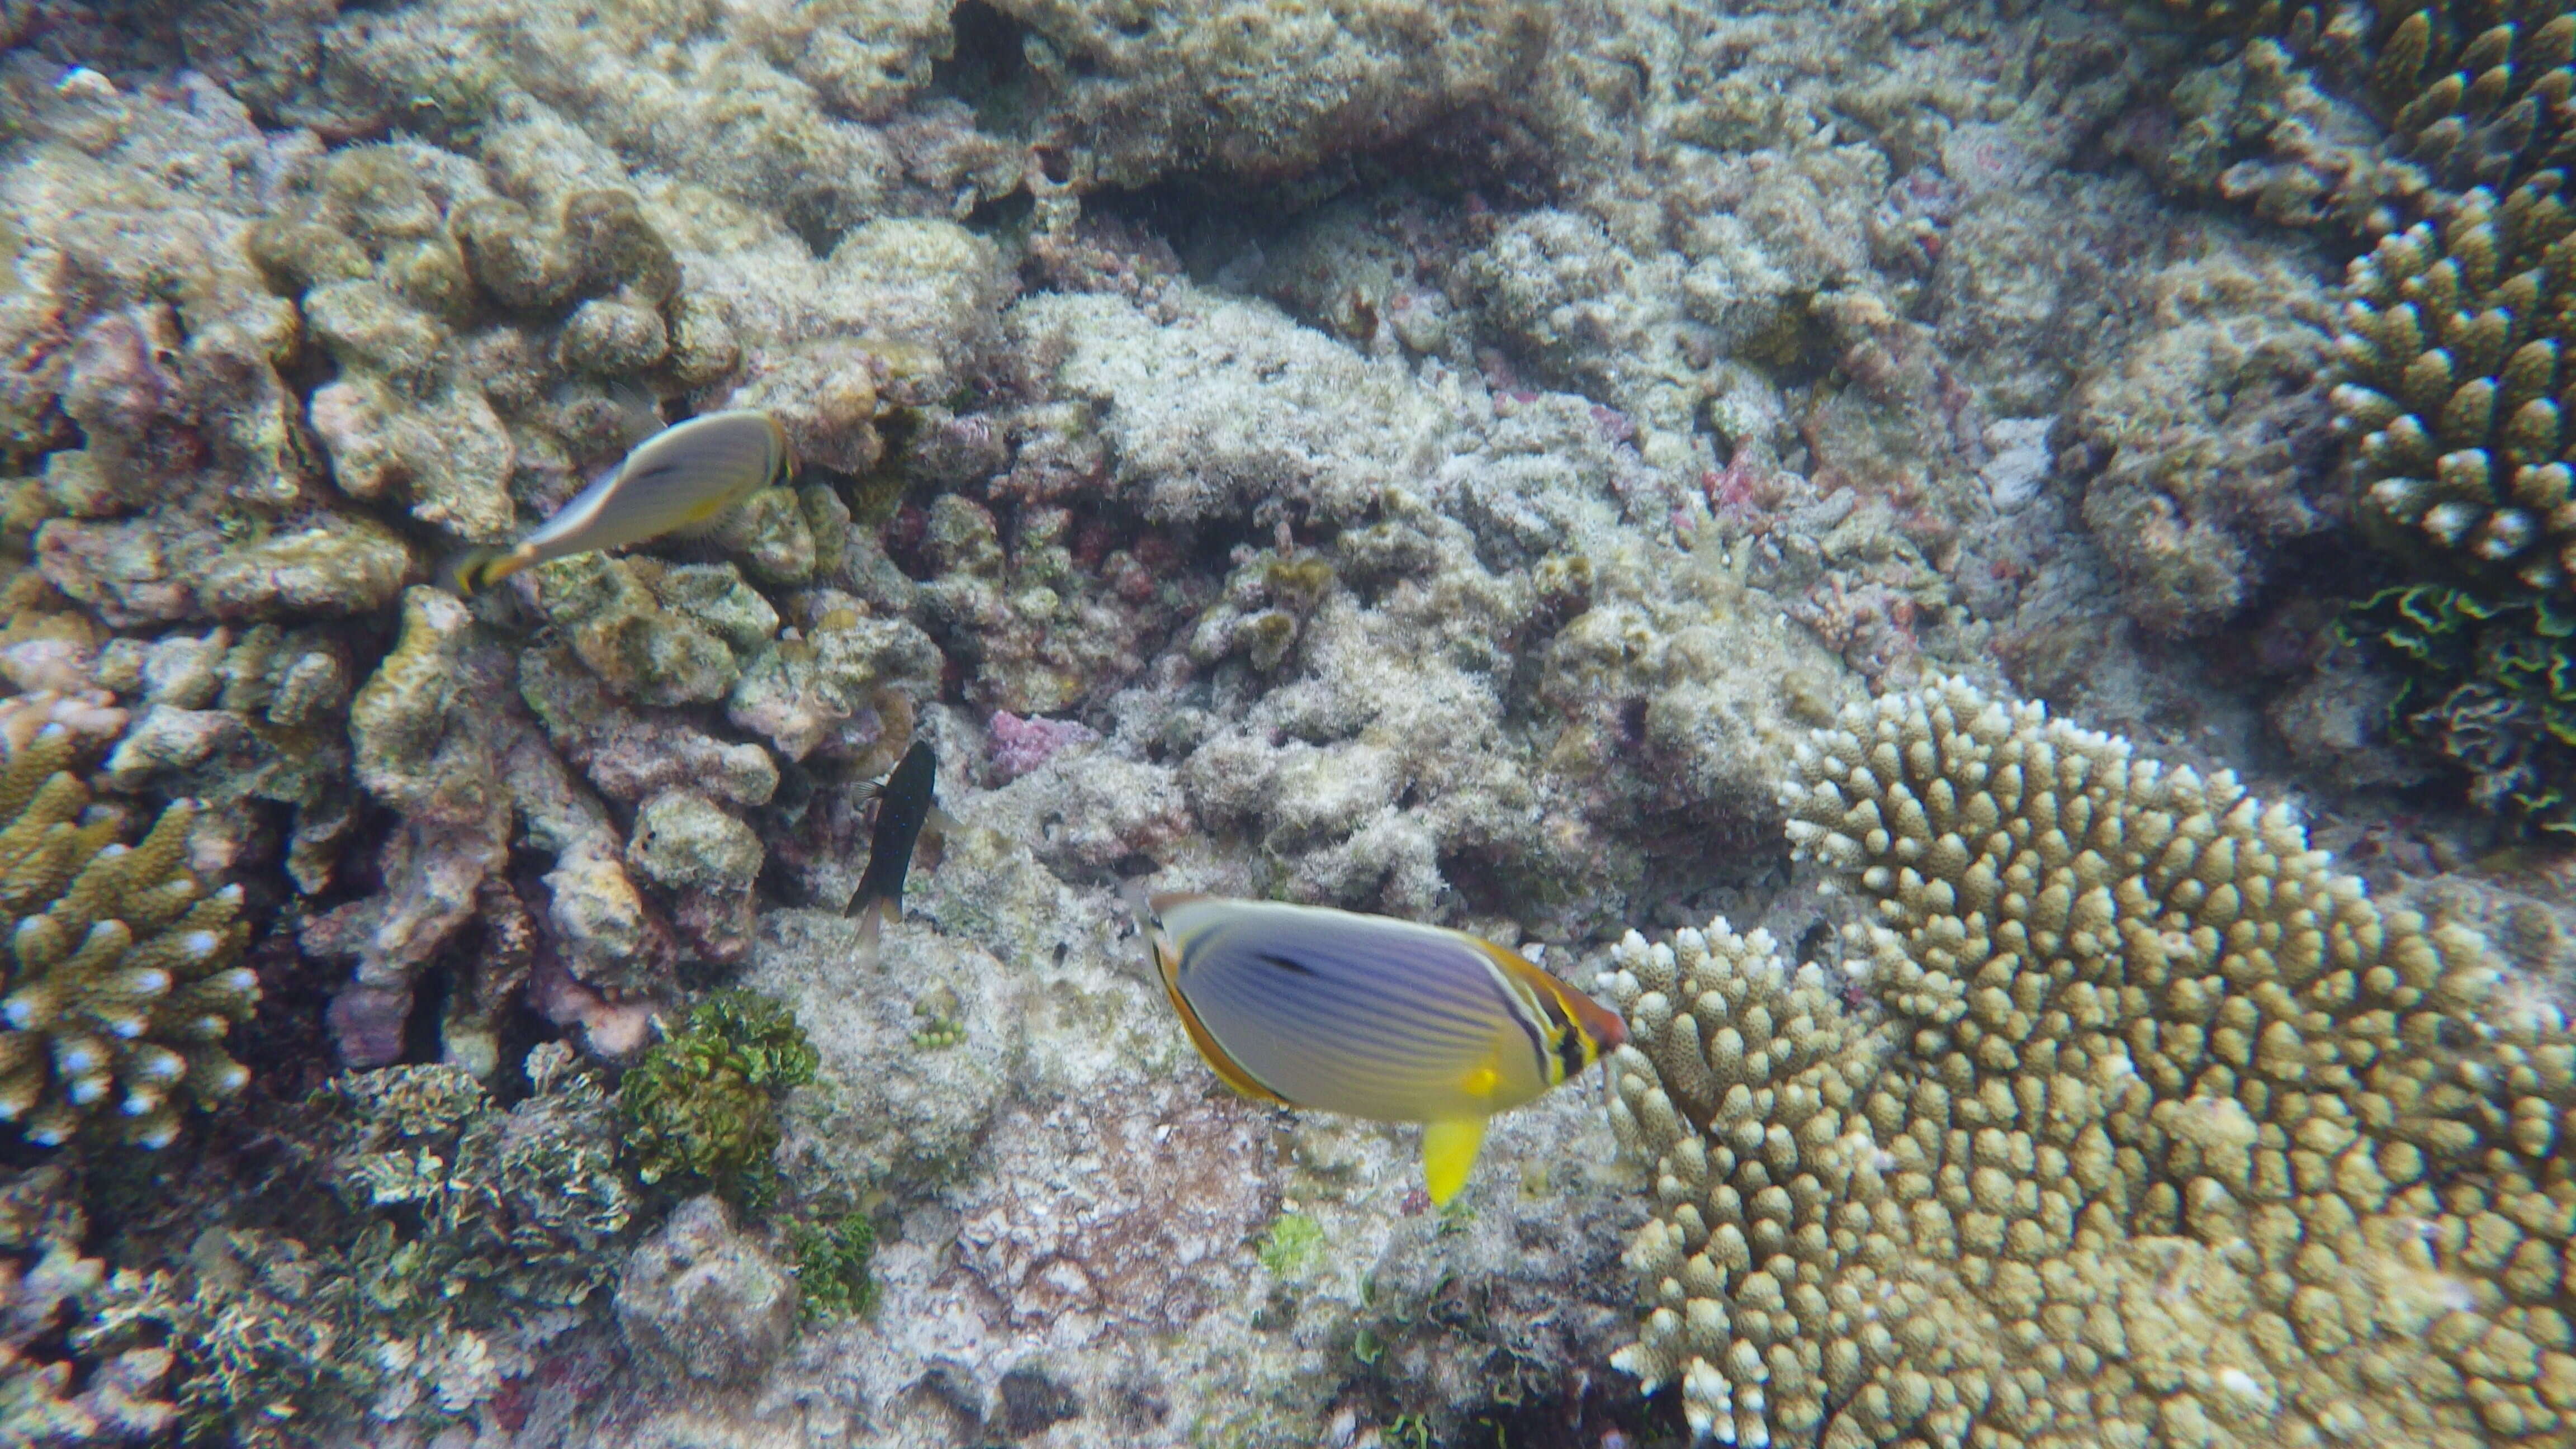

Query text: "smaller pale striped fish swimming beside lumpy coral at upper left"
[441, 408, 796, 593]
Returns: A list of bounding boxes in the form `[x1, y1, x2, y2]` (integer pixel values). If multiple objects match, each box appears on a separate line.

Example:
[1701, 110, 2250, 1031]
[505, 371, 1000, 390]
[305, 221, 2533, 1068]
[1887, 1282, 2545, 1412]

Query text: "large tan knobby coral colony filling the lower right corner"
[1613, 681, 2576, 1449]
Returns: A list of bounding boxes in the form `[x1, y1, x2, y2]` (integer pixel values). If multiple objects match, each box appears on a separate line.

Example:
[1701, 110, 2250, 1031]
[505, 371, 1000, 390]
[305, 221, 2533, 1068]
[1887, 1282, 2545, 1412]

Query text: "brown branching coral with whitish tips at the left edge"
[0, 730, 260, 1147]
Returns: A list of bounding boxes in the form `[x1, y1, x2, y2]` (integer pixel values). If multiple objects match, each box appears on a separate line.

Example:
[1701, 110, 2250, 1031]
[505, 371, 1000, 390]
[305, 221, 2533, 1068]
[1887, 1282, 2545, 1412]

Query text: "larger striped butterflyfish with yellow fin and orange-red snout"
[1152, 894, 1628, 1204]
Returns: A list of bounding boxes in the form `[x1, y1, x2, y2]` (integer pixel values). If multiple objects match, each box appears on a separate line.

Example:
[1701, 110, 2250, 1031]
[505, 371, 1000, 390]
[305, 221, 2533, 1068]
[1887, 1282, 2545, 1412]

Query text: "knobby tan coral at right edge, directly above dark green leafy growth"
[2334, 175, 2576, 590]
